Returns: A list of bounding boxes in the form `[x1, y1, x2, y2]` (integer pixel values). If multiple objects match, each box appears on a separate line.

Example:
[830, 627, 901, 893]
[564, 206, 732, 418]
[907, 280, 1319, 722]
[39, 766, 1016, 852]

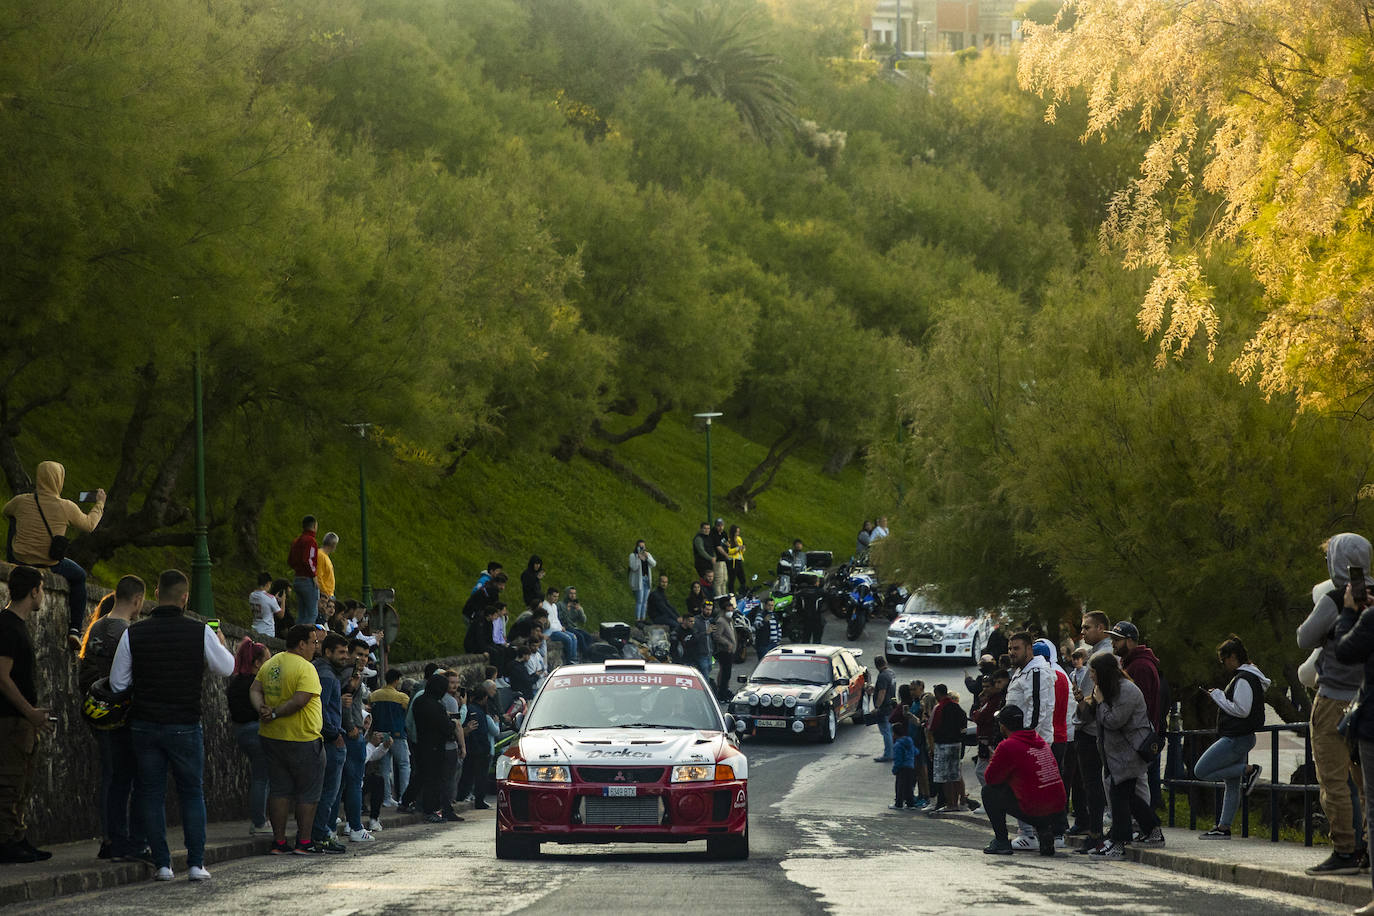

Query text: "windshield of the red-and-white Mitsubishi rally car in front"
[525, 673, 721, 732]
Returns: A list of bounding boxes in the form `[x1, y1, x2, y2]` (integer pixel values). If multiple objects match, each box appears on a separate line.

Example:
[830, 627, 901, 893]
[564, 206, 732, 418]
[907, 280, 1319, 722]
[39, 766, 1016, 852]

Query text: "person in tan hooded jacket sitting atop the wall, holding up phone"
[3, 461, 104, 652]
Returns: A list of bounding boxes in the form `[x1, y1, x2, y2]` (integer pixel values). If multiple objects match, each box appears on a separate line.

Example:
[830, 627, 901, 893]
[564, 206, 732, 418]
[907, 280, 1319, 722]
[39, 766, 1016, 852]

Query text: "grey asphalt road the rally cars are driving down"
[12, 612, 1345, 916]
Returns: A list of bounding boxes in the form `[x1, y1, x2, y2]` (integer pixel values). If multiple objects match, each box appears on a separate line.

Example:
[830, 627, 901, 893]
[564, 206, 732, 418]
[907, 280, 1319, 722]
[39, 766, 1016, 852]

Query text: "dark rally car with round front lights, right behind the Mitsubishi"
[730, 644, 868, 743]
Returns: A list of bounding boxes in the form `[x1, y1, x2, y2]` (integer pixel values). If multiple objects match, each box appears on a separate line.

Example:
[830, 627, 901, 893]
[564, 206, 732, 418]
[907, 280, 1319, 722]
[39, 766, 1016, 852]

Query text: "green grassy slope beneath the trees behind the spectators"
[69, 417, 863, 658]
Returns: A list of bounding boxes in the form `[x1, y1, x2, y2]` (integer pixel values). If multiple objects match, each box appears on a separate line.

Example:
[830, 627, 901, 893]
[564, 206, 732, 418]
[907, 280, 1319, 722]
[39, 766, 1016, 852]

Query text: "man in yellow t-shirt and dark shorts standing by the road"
[250, 623, 324, 856]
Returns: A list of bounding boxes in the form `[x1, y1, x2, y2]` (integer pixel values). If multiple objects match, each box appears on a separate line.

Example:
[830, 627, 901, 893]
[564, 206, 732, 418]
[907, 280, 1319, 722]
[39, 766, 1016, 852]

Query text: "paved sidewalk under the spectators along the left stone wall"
[0, 808, 423, 906]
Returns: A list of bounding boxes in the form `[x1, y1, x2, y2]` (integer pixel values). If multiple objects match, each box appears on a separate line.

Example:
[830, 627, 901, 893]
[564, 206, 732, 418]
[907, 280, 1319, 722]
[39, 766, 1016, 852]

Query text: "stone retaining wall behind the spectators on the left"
[0, 563, 481, 845]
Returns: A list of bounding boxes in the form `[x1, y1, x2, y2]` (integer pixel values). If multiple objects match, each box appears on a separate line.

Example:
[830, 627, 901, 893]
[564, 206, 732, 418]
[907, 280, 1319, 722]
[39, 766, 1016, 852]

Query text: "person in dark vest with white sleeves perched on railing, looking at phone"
[1193, 634, 1270, 839]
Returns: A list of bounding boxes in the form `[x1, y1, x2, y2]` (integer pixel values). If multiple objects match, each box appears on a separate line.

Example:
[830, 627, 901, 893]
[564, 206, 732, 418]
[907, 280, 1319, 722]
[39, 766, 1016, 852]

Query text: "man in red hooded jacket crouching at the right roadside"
[982, 706, 1066, 856]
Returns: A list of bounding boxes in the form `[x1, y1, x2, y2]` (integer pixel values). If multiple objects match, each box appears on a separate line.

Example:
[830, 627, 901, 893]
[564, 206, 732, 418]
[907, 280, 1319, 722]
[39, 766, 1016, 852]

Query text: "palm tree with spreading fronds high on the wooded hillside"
[651, 4, 797, 143]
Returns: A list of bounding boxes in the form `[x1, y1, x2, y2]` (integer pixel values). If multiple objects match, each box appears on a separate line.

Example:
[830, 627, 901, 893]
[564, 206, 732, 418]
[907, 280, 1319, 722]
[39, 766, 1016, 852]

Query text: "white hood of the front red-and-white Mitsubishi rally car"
[519, 728, 730, 766]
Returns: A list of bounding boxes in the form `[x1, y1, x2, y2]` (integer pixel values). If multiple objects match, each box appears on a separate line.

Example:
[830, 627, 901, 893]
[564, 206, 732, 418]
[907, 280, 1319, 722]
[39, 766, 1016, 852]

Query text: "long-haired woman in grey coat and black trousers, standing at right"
[1084, 652, 1164, 858]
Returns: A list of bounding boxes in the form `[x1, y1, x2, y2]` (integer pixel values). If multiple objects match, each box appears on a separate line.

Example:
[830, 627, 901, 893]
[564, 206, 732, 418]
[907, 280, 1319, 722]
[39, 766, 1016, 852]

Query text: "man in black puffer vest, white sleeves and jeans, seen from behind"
[110, 570, 234, 882]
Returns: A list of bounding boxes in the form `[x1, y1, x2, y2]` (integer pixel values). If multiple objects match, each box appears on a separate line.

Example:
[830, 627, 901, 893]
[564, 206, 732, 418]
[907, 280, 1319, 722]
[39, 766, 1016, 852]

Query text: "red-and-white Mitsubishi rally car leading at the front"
[496, 659, 749, 858]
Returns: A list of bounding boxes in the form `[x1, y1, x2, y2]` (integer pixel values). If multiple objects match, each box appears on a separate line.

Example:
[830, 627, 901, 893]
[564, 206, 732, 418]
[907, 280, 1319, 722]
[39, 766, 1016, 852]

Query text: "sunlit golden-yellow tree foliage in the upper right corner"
[1020, 0, 1374, 408]
